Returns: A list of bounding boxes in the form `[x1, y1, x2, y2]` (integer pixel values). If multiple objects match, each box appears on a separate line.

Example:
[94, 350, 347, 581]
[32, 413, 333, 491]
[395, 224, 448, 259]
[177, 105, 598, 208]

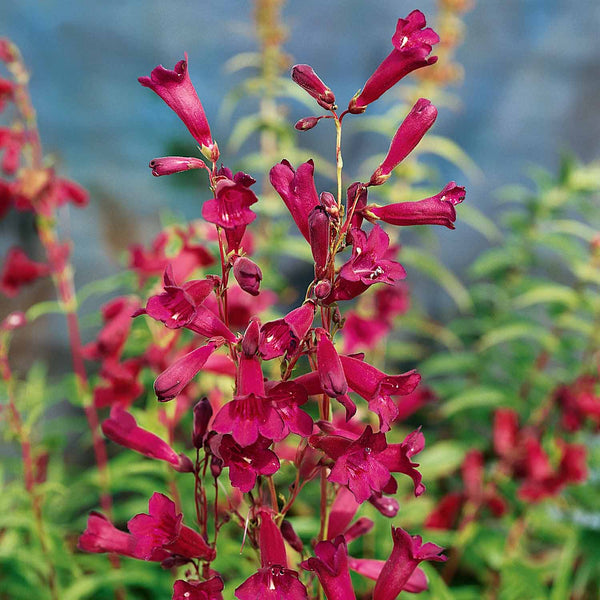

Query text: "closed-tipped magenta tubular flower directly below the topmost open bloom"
[367, 98, 437, 185]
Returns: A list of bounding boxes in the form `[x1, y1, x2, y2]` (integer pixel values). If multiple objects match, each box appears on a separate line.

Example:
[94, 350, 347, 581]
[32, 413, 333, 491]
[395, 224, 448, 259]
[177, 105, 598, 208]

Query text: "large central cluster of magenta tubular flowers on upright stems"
[79, 11, 464, 600]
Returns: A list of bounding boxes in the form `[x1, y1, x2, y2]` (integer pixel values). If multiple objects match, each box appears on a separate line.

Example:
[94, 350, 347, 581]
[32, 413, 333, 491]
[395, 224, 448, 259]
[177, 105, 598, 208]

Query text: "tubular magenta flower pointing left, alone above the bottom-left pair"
[102, 406, 194, 472]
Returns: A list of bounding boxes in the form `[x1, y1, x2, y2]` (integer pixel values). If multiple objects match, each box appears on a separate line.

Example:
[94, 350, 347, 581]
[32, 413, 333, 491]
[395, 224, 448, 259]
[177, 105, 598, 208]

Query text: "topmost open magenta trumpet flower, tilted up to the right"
[348, 10, 440, 113]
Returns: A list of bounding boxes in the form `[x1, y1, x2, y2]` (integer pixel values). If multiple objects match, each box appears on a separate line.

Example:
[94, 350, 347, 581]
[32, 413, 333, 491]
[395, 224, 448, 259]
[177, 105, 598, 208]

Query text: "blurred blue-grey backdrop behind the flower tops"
[0, 0, 600, 352]
